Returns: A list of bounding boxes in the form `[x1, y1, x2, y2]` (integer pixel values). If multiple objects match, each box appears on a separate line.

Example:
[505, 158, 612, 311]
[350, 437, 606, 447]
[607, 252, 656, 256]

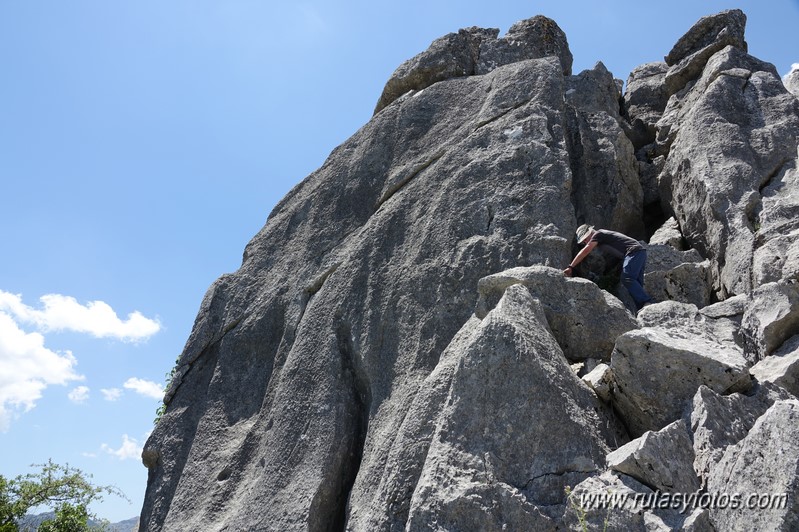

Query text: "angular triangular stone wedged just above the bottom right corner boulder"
[690, 384, 790, 488]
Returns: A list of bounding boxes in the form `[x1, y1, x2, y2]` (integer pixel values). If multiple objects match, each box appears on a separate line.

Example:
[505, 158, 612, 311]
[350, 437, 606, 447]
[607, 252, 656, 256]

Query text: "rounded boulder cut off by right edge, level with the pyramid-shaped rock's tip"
[741, 279, 799, 364]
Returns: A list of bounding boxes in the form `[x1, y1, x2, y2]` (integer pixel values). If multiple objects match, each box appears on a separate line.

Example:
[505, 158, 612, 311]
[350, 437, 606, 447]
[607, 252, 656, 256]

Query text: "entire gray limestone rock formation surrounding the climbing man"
[141, 11, 799, 531]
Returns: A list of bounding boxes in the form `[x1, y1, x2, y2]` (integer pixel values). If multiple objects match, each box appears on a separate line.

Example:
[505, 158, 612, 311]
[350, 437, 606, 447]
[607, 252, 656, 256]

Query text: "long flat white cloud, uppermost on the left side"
[0, 290, 161, 341]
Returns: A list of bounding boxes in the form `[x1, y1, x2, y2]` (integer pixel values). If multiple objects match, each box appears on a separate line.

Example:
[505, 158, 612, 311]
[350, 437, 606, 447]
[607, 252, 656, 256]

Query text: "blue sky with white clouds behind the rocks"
[0, 0, 799, 521]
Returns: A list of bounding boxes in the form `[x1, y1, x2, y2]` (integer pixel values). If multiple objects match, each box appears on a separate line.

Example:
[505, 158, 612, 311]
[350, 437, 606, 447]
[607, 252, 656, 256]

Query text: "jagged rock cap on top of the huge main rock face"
[375, 15, 573, 113]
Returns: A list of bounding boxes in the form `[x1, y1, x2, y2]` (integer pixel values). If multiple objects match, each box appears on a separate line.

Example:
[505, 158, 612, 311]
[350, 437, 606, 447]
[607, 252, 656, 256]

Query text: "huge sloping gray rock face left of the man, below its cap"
[142, 58, 590, 530]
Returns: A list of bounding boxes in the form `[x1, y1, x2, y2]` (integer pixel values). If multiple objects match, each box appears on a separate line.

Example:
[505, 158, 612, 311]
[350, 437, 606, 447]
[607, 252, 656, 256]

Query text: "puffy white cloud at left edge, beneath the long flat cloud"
[0, 312, 83, 432]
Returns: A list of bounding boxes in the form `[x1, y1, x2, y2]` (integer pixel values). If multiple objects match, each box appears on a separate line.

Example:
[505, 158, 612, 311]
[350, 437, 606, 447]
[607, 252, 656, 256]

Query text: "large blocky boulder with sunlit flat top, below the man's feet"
[610, 328, 751, 437]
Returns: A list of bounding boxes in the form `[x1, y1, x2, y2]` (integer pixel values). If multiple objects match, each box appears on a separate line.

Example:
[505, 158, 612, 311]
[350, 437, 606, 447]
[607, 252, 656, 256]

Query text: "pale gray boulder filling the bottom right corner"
[707, 398, 799, 531]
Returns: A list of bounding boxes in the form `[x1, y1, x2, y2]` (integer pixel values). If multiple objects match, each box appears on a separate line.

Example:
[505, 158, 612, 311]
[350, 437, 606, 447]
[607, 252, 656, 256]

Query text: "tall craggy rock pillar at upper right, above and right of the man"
[658, 46, 799, 299]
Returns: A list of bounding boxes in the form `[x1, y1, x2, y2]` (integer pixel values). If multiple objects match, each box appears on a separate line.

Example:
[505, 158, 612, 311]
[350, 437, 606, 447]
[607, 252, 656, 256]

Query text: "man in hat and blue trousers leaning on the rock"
[563, 224, 652, 312]
